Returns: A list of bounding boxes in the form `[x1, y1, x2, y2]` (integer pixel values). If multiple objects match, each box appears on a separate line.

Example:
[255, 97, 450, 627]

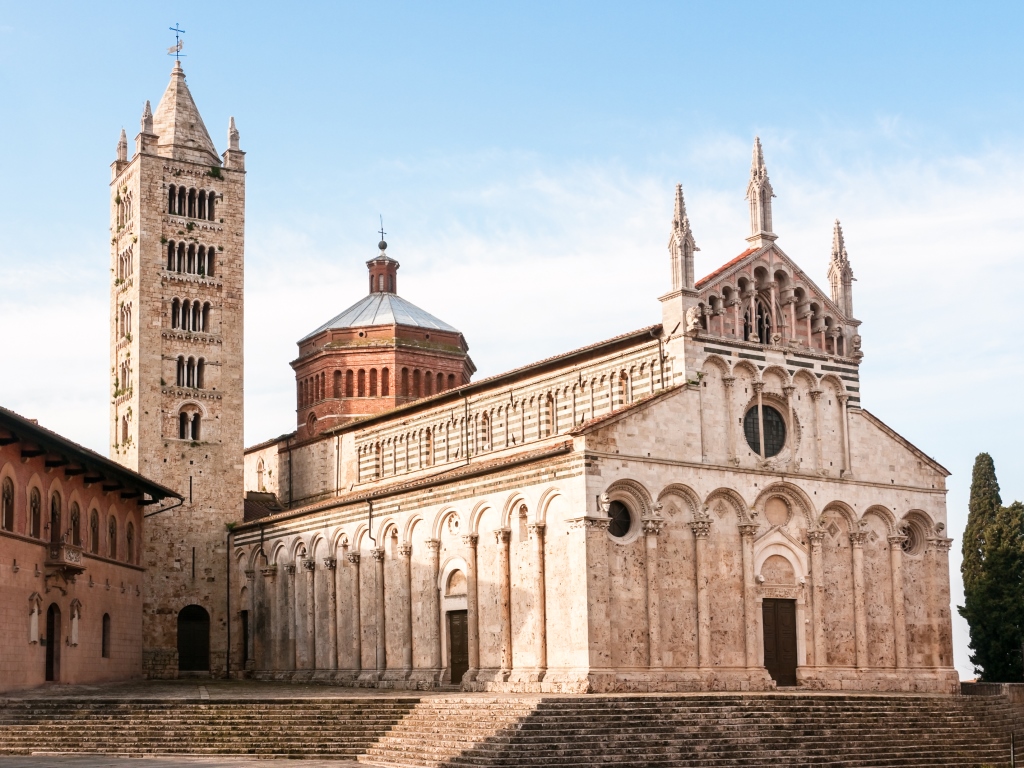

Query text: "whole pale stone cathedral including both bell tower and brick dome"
[90, 63, 957, 693]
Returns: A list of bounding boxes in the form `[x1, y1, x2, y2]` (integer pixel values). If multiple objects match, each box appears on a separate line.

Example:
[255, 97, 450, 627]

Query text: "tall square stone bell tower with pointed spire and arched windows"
[110, 61, 246, 677]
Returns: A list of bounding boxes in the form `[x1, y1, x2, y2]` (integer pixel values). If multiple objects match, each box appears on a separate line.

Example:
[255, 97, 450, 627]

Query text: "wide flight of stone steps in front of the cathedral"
[0, 693, 1024, 768]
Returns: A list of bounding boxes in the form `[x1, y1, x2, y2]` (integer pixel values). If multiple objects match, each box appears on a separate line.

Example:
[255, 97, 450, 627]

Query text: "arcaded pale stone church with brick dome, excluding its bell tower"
[234, 142, 957, 692]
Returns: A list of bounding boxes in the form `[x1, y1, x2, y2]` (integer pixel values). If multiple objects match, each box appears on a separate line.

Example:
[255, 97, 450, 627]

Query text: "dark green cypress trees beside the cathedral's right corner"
[958, 454, 1024, 682]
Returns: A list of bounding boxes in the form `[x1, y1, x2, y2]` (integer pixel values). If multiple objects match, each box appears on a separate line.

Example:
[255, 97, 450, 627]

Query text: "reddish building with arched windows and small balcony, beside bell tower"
[0, 408, 181, 691]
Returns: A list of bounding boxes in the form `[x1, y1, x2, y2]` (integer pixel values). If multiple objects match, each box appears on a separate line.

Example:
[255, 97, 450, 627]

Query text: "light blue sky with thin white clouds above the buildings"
[0, 2, 1024, 676]
